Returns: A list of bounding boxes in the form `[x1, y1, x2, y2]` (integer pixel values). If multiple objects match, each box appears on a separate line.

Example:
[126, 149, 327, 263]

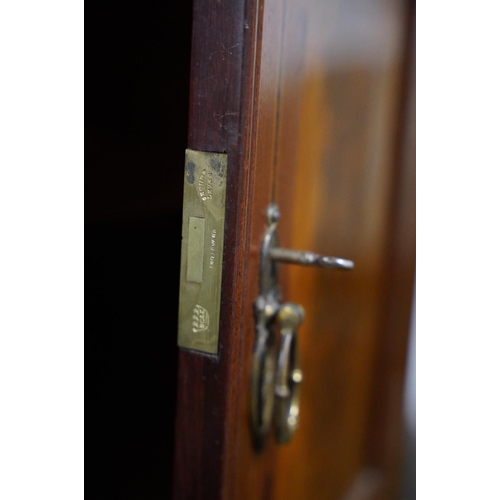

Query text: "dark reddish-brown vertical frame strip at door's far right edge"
[367, 3, 416, 500]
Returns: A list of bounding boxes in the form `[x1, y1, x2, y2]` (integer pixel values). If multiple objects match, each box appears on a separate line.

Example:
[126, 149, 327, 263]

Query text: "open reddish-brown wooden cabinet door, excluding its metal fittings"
[174, 0, 415, 500]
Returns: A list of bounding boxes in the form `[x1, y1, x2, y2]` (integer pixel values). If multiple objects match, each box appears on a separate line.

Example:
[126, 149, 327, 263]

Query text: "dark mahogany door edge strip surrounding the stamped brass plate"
[171, 0, 266, 500]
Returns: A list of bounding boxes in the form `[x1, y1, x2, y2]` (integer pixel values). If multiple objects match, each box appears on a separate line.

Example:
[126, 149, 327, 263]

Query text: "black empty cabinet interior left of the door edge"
[85, 1, 192, 500]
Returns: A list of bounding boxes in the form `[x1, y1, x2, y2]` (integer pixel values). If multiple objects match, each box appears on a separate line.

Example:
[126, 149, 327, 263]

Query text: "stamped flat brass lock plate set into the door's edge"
[177, 149, 227, 354]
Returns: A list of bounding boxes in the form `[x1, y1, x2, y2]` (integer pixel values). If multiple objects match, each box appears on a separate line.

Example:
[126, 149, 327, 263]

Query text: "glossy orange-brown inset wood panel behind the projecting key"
[275, 1, 413, 499]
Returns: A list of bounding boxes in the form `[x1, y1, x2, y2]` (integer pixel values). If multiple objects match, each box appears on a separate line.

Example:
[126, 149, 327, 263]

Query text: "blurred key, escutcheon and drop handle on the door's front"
[250, 204, 354, 449]
